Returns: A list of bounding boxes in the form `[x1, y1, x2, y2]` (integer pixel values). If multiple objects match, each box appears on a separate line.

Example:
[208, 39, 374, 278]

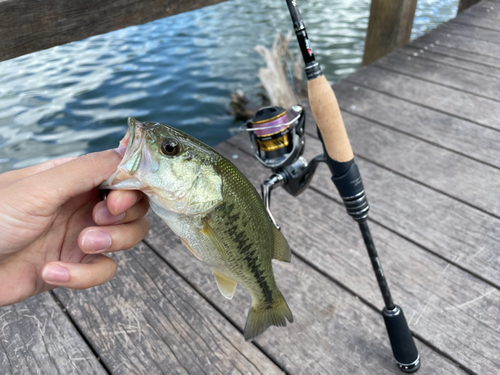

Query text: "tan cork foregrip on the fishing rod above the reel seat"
[307, 75, 354, 163]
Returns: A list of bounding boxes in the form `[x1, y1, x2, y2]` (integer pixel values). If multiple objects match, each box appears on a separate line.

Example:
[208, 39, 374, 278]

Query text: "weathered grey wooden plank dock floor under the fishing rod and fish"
[0, 0, 500, 374]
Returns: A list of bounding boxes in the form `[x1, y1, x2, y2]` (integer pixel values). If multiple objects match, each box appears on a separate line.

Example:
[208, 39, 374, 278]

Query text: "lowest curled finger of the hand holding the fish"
[42, 254, 116, 289]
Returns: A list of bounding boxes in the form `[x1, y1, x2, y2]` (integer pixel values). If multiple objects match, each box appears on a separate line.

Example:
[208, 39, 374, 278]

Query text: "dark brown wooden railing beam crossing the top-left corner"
[0, 0, 229, 61]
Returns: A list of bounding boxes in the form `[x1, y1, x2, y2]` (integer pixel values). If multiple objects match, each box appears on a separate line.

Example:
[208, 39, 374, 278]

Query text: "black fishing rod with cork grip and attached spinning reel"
[241, 0, 420, 373]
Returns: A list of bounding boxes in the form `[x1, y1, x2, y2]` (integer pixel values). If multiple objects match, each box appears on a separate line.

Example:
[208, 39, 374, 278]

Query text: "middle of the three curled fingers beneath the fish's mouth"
[78, 217, 149, 254]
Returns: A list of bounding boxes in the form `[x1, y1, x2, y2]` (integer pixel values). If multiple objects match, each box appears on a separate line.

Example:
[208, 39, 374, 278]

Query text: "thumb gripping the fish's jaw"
[21, 149, 123, 214]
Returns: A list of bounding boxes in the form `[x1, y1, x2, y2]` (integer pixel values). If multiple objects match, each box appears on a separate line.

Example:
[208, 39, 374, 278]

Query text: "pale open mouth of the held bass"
[99, 117, 156, 190]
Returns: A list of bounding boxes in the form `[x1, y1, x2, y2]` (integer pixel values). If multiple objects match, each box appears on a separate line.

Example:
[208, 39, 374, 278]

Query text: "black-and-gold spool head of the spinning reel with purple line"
[240, 105, 305, 169]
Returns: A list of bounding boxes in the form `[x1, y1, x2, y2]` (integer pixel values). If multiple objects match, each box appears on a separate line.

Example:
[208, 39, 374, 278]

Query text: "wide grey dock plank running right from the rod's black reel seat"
[276, 137, 500, 286]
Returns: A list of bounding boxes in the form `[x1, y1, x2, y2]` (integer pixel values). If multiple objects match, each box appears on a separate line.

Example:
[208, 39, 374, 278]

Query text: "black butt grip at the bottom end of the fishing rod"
[382, 306, 420, 373]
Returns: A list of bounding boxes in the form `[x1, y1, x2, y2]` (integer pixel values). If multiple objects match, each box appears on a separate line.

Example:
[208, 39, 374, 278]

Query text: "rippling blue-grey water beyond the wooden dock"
[0, 0, 458, 172]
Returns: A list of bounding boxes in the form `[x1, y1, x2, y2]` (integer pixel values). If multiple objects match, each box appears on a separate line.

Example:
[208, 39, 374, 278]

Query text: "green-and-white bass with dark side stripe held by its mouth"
[101, 118, 293, 341]
